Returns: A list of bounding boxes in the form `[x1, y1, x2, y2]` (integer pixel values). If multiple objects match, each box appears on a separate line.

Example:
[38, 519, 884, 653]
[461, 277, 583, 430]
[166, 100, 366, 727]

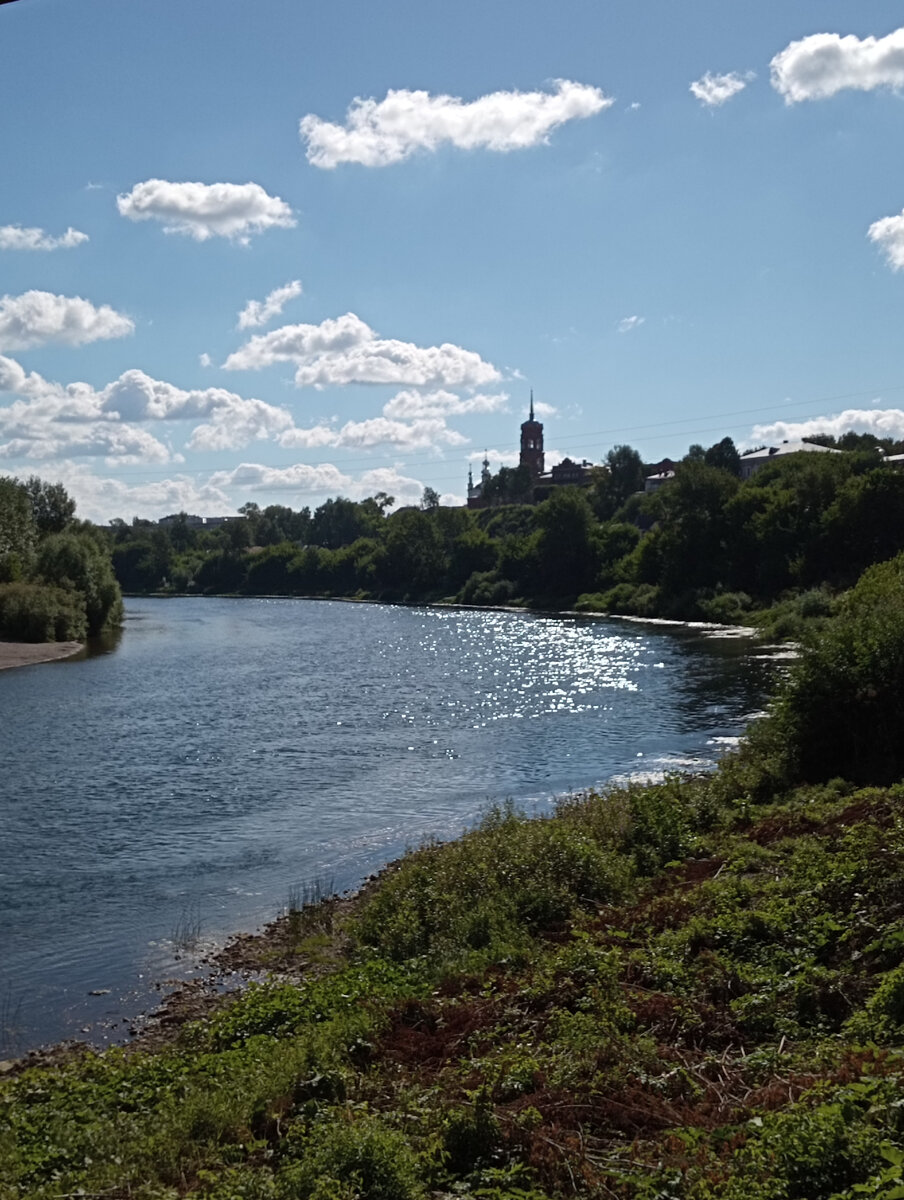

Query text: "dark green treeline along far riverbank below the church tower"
[113, 434, 904, 635]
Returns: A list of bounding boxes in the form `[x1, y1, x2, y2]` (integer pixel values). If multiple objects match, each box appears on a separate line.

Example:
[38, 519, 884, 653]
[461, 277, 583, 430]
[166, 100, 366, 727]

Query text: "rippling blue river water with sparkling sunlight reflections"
[0, 599, 774, 1054]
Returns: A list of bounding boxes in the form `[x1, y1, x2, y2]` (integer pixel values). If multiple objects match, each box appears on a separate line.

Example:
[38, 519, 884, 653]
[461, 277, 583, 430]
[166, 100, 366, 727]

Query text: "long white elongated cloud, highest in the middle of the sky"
[299, 79, 613, 169]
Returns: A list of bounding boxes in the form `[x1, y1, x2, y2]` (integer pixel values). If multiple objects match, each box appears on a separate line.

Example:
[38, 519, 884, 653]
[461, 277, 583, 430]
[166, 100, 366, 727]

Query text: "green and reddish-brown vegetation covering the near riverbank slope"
[0, 554, 904, 1200]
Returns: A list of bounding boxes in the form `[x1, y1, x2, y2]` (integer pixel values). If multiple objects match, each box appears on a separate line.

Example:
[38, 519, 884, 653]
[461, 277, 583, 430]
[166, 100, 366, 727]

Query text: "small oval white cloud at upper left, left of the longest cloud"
[116, 179, 295, 244]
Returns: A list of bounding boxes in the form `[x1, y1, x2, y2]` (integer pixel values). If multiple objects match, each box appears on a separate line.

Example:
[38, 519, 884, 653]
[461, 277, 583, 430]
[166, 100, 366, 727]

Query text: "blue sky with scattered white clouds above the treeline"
[0, 0, 904, 522]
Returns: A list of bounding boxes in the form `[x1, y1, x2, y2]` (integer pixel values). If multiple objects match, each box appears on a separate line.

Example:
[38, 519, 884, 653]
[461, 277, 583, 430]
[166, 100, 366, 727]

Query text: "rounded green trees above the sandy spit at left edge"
[0, 475, 122, 642]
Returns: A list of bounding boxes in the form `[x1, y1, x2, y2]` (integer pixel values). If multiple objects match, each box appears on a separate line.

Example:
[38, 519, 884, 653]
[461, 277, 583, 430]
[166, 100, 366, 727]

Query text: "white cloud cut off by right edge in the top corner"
[770, 29, 904, 104]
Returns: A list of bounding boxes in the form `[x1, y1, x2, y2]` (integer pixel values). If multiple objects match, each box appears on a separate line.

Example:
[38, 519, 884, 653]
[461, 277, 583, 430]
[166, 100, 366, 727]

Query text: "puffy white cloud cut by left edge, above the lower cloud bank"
[0, 292, 134, 350]
